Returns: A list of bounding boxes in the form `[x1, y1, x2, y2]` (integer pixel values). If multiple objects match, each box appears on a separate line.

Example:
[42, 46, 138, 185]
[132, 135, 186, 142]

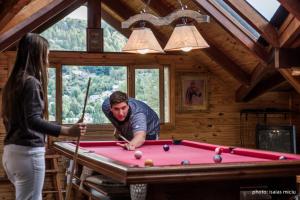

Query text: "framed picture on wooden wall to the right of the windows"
[179, 73, 208, 111]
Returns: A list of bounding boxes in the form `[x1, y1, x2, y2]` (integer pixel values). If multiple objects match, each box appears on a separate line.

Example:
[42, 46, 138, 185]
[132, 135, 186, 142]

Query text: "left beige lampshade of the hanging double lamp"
[122, 27, 164, 54]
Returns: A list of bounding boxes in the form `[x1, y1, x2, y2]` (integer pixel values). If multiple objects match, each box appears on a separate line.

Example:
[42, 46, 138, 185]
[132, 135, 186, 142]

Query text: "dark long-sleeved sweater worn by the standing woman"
[4, 76, 61, 147]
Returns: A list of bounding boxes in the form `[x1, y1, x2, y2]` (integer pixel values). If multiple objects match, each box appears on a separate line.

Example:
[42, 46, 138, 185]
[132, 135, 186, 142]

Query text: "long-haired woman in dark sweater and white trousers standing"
[2, 33, 86, 200]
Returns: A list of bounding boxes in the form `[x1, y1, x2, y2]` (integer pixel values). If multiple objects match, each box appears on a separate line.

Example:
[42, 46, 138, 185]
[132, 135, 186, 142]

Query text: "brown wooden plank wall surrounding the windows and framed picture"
[0, 52, 300, 199]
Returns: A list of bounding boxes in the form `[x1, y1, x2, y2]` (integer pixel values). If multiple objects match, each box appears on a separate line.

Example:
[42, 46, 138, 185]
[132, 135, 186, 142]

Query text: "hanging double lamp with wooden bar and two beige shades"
[122, 0, 209, 54]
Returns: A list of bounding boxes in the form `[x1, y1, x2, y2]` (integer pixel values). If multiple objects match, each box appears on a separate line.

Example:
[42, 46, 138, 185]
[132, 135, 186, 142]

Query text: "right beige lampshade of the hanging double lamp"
[164, 25, 209, 51]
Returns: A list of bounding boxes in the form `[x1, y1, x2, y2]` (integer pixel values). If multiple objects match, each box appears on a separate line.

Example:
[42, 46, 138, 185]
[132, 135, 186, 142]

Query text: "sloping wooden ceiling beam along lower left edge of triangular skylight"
[225, 0, 279, 47]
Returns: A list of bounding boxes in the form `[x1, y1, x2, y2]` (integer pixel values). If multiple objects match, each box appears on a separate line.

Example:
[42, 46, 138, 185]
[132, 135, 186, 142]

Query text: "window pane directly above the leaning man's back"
[135, 69, 160, 116]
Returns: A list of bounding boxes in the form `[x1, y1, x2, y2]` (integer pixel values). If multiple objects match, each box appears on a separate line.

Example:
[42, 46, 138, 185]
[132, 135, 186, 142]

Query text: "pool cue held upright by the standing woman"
[66, 78, 91, 200]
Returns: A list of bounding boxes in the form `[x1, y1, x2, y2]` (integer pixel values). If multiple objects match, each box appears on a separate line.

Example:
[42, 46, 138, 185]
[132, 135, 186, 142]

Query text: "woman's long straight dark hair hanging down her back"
[1, 33, 49, 123]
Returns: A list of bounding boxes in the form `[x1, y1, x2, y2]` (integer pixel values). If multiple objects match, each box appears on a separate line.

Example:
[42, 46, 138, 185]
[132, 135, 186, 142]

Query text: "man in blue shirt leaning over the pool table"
[102, 91, 160, 150]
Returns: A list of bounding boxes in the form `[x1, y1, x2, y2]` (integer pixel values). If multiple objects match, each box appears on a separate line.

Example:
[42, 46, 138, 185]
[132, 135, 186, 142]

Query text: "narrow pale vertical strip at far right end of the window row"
[164, 67, 170, 123]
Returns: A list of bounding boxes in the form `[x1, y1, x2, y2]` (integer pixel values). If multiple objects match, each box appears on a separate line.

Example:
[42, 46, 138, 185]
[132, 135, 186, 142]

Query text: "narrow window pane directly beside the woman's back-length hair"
[48, 68, 56, 121]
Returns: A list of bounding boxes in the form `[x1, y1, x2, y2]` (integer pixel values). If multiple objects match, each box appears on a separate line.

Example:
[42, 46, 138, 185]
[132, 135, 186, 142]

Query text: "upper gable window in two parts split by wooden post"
[41, 6, 127, 52]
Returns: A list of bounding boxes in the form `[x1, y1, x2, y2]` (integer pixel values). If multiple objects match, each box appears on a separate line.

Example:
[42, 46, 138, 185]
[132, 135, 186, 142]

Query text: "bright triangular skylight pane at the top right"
[246, 0, 280, 21]
